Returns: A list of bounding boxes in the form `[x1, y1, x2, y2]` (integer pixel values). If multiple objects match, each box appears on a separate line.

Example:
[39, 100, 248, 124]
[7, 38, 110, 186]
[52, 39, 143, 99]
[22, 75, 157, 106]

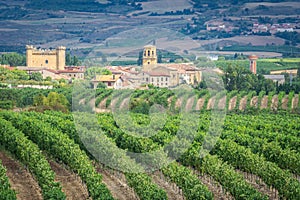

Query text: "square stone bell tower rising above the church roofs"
[143, 45, 157, 71]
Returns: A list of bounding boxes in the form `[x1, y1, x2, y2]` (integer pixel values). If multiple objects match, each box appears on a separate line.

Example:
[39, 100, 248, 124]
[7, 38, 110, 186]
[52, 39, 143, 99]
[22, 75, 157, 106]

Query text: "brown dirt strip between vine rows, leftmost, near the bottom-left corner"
[0, 151, 43, 200]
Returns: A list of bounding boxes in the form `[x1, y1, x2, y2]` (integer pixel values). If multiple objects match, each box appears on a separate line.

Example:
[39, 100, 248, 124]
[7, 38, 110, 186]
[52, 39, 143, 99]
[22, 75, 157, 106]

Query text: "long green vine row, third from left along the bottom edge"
[2, 112, 113, 199]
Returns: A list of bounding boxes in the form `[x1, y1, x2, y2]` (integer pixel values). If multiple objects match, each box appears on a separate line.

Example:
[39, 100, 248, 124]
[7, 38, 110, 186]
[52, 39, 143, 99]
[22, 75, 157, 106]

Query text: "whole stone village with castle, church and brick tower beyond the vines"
[2, 45, 290, 89]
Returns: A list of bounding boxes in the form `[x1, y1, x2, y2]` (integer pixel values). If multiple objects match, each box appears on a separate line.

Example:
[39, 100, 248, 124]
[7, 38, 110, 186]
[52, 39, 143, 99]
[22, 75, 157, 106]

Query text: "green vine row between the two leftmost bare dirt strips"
[0, 117, 66, 199]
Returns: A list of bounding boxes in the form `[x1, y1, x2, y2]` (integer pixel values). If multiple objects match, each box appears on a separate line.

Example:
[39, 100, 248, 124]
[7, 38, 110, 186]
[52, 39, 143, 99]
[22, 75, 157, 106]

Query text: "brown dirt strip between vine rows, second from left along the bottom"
[49, 160, 89, 200]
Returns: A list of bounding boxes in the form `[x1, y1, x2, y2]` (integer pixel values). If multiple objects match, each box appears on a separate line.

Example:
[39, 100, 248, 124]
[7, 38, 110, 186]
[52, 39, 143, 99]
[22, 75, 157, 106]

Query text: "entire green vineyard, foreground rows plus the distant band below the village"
[0, 90, 300, 200]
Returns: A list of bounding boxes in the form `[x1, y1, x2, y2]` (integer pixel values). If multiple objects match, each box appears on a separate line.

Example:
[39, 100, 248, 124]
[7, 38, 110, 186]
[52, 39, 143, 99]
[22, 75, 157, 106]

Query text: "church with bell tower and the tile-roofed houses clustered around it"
[93, 45, 201, 89]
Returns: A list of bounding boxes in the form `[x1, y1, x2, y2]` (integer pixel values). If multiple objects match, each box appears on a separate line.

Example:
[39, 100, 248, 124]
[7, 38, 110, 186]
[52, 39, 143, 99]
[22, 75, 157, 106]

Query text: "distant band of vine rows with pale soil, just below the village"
[86, 89, 300, 114]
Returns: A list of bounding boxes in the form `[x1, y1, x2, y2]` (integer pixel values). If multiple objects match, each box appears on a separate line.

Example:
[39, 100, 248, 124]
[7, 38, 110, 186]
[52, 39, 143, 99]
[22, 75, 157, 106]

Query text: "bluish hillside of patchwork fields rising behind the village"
[0, 0, 300, 57]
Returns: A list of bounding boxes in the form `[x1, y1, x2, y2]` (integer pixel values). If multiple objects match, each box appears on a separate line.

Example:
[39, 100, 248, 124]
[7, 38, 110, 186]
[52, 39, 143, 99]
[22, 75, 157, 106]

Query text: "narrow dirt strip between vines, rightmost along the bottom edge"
[236, 170, 279, 200]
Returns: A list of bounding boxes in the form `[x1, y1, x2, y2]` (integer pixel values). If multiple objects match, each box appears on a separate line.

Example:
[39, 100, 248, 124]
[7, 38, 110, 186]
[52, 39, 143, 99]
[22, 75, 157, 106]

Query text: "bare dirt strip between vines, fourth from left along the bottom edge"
[151, 171, 184, 200]
